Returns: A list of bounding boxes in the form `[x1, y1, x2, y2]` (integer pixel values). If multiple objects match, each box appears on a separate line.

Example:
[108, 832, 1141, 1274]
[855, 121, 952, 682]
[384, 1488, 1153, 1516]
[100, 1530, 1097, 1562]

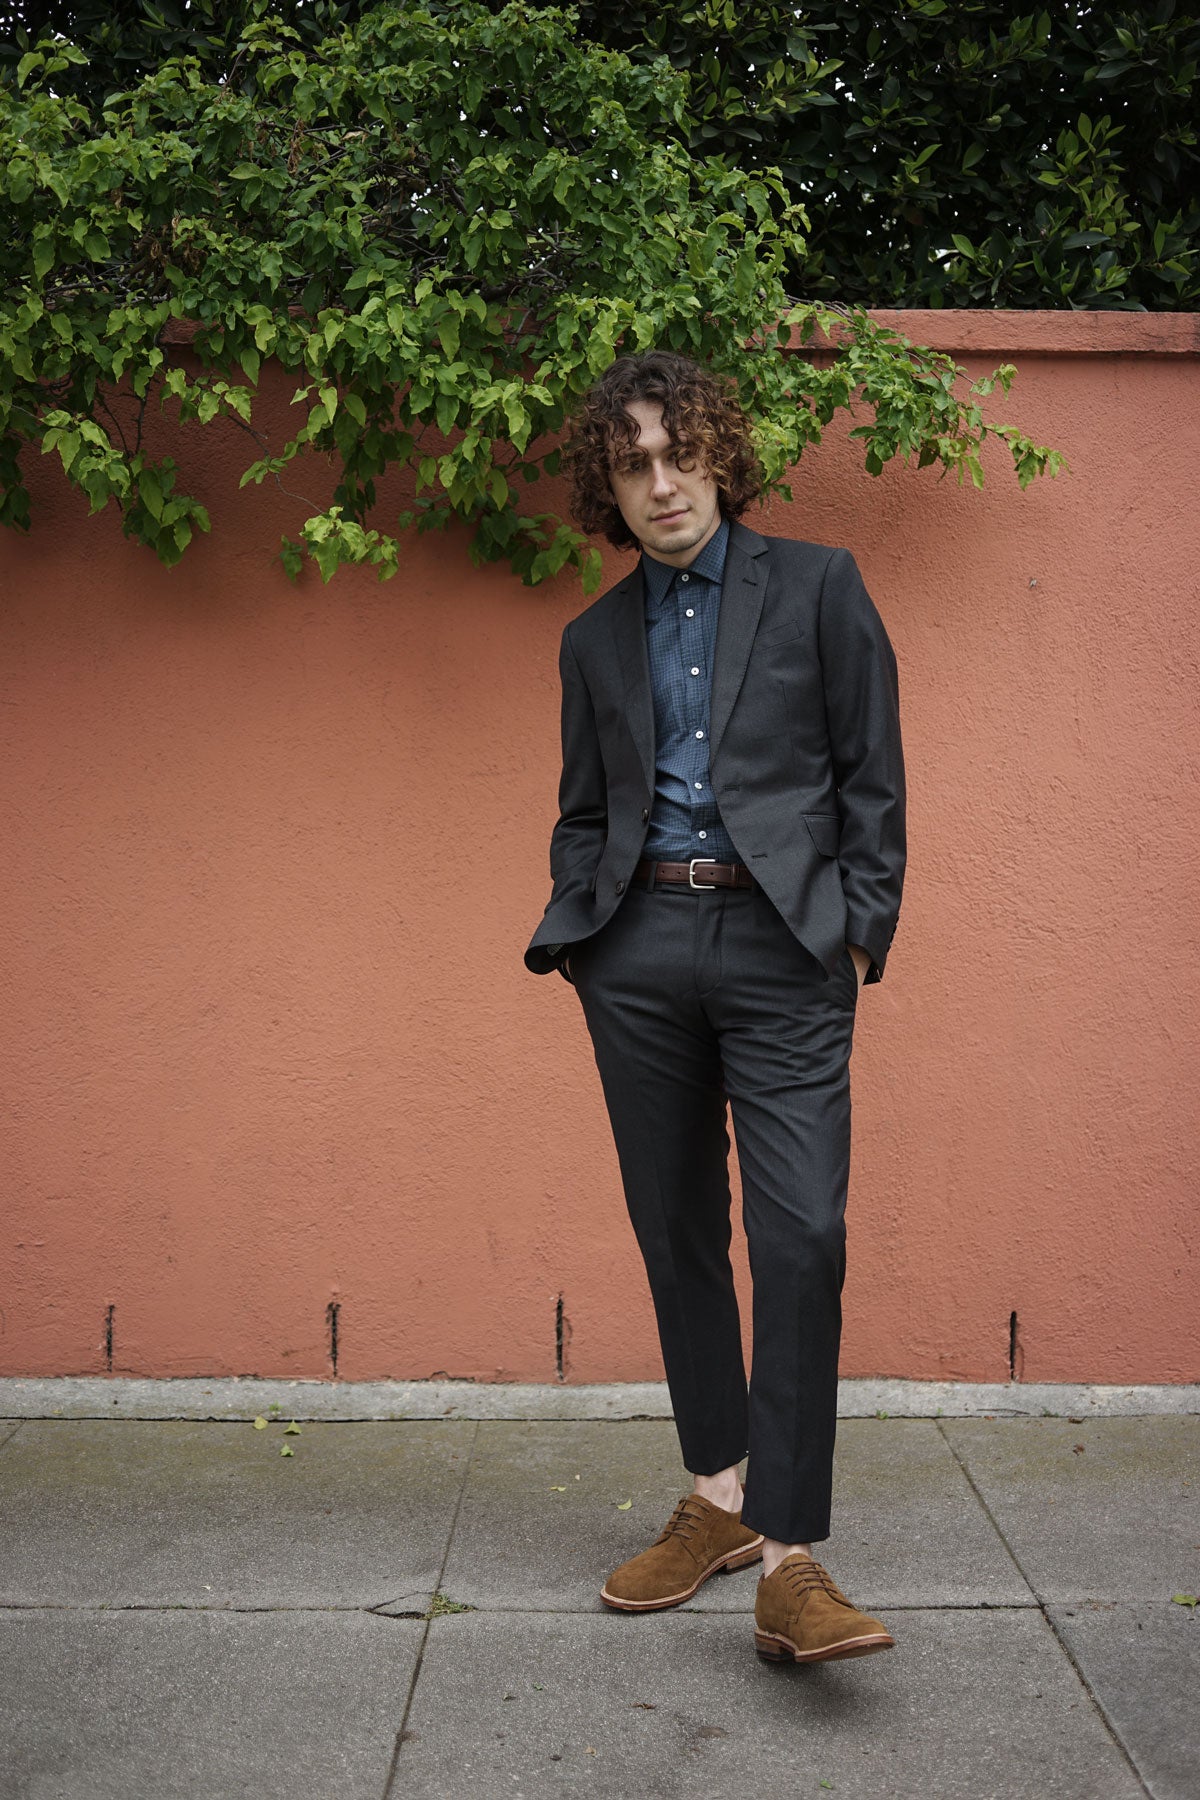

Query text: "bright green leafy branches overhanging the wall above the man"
[0, 4, 1061, 587]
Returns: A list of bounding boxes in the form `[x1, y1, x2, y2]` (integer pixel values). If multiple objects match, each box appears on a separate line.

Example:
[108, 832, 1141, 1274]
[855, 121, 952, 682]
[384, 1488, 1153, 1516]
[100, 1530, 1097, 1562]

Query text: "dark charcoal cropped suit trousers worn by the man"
[570, 871, 858, 1543]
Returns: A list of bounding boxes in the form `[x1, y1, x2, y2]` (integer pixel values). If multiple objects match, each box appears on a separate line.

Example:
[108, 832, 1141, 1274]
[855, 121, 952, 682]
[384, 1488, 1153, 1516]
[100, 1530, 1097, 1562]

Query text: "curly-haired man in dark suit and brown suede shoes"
[525, 353, 905, 1661]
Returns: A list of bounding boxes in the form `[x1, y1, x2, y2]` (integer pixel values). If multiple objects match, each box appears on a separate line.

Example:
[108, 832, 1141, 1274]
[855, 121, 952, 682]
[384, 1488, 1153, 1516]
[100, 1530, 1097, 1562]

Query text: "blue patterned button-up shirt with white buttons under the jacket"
[642, 518, 741, 864]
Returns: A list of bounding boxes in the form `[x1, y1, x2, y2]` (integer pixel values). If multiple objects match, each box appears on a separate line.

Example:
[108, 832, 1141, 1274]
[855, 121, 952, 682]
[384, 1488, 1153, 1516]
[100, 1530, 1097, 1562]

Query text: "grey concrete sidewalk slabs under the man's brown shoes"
[0, 1382, 1200, 1800]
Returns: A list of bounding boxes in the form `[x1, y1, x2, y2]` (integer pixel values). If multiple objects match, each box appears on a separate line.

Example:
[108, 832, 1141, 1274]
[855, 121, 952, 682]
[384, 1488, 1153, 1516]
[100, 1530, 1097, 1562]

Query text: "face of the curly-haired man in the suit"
[608, 400, 721, 569]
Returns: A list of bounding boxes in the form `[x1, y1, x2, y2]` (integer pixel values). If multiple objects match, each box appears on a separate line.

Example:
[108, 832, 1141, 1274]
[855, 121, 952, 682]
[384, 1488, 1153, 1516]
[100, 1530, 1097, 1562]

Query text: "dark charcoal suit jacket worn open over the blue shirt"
[525, 524, 905, 981]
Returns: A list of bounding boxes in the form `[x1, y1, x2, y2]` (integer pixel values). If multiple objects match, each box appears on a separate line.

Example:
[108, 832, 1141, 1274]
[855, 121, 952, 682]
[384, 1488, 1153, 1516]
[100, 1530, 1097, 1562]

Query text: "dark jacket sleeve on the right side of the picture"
[819, 551, 907, 981]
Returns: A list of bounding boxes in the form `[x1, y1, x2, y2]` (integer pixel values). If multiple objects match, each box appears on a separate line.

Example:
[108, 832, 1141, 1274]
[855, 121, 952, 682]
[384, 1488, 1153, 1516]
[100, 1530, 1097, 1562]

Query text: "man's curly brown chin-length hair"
[565, 349, 763, 549]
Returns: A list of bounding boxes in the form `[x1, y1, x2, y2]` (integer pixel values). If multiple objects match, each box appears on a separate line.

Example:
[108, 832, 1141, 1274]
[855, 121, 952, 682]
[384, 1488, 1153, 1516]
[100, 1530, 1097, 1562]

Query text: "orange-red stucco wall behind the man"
[0, 315, 1200, 1382]
